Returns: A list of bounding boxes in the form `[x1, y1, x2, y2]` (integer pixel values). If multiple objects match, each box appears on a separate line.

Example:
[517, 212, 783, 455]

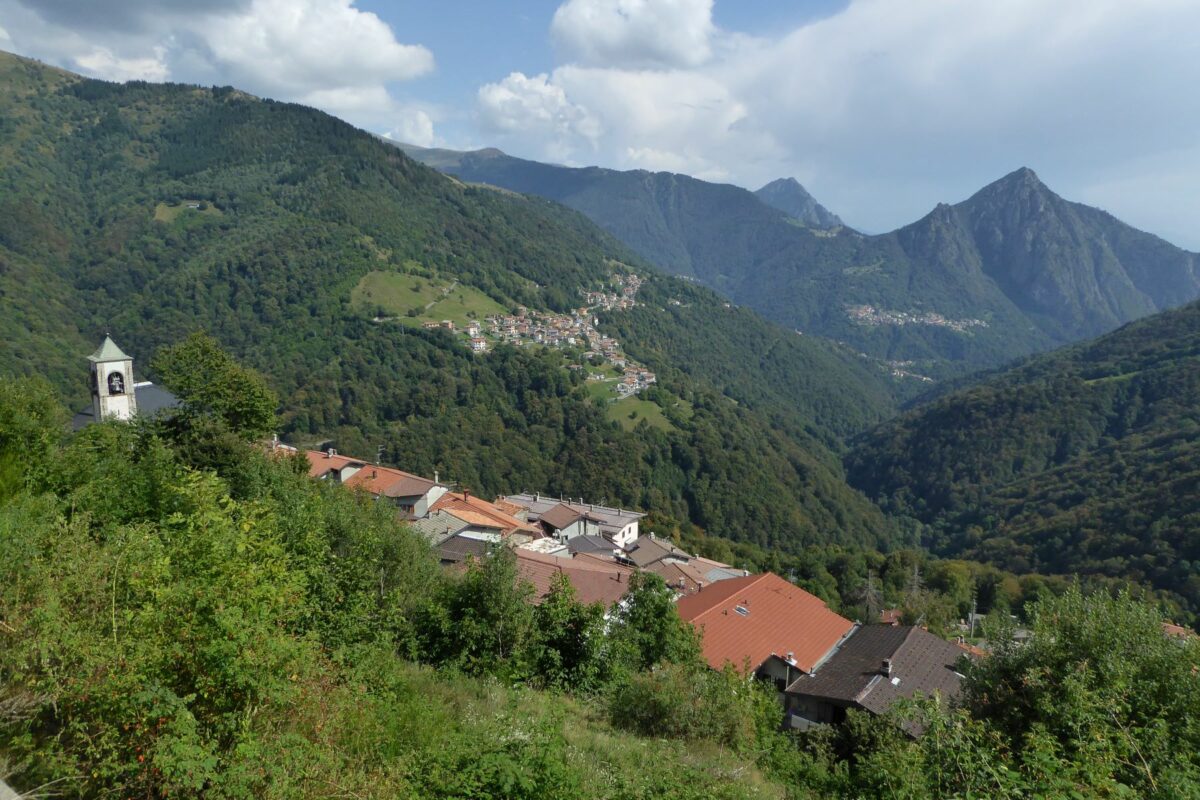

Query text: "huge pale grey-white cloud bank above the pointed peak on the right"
[480, 0, 1200, 248]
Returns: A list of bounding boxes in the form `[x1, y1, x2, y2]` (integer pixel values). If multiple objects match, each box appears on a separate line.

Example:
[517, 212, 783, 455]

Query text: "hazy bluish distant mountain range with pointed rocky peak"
[404, 145, 1200, 377]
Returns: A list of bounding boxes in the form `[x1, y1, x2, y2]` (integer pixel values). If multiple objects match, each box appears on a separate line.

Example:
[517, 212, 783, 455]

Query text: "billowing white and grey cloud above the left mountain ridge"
[0, 0, 433, 126]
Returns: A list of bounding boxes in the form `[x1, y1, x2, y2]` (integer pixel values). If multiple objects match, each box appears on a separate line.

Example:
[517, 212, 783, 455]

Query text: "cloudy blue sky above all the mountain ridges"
[0, 0, 1200, 249]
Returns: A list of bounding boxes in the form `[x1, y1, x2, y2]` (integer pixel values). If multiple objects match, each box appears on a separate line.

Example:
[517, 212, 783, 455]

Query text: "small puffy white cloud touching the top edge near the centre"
[551, 0, 716, 68]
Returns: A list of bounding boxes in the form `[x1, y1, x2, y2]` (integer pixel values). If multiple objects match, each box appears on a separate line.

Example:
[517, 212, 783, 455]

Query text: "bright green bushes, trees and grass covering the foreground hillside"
[0, 352, 1200, 800]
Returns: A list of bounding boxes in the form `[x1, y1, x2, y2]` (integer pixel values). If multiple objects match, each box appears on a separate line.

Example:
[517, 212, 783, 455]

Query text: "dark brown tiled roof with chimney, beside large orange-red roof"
[787, 625, 966, 714]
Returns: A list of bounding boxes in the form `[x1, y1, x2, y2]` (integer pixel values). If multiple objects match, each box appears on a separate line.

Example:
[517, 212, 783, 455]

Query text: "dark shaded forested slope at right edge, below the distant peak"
[848, 303, 1200, 610]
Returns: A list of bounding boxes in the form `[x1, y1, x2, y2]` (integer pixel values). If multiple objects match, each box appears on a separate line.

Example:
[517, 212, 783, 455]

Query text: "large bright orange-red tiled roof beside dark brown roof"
[677, 572, 854, 672]
